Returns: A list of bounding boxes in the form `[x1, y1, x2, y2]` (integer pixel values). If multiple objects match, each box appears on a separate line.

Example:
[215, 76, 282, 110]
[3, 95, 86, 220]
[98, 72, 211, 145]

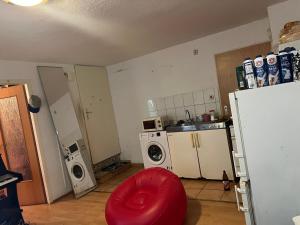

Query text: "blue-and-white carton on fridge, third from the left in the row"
[254, 55, 269, 87]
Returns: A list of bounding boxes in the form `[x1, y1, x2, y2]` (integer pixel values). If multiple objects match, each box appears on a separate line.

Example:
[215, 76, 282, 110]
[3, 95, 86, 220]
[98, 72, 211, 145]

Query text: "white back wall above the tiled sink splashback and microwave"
[107, 19, 269, 163]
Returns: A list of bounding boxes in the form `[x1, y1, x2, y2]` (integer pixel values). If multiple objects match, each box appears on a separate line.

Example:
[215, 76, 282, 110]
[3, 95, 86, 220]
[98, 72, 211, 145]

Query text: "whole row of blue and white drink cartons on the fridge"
[236, 47, 300, 90]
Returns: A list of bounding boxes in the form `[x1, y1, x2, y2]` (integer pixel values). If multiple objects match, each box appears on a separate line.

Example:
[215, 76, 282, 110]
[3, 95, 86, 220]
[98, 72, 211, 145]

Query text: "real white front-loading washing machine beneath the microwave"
[140, 131, 172, 171]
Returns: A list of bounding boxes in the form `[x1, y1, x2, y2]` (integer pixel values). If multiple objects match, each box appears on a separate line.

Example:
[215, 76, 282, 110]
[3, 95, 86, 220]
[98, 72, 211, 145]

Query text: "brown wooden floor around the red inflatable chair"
[22, 166, 245, 225]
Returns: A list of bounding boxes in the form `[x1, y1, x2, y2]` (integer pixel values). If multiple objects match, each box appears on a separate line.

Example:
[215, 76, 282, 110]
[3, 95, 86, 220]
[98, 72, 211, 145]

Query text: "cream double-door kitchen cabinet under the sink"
[168, 129, 234, 180]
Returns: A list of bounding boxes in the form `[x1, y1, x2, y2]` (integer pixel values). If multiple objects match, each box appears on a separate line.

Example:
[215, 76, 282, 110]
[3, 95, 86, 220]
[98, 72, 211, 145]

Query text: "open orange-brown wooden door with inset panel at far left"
[0, 85, 46, 205]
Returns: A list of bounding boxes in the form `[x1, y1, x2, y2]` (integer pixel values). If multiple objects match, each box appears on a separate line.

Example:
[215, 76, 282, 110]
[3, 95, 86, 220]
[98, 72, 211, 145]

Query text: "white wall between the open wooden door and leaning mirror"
[0, 60, 74, 202]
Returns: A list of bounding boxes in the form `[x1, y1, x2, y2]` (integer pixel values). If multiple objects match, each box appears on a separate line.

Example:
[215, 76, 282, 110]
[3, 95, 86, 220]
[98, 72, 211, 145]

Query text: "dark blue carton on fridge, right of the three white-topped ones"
[279, 51, 294, 83]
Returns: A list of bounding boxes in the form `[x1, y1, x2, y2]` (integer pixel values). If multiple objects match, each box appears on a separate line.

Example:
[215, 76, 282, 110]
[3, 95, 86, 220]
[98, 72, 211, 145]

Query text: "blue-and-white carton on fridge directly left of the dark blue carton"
[267, 52, 281, 85]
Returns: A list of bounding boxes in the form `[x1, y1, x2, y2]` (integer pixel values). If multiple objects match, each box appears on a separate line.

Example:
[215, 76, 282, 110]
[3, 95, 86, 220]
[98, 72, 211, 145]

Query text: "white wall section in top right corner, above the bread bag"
[268, 0, 300, 46]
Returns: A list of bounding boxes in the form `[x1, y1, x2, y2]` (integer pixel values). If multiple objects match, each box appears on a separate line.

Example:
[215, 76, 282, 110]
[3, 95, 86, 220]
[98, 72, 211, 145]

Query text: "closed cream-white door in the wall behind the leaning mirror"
[75, 66, 120, 164]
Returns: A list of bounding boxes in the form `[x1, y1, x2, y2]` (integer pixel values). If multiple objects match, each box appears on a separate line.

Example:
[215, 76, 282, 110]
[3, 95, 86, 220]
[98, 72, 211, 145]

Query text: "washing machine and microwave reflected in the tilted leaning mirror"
[65, 140, 97, 198]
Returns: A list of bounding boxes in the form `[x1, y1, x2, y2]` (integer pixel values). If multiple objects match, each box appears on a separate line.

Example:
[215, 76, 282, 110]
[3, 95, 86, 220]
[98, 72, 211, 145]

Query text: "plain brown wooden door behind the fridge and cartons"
[215, 42, 271, 115]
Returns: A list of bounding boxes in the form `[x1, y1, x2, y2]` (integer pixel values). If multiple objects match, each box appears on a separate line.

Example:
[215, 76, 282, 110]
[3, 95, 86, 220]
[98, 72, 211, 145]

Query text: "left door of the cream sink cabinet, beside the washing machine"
[168, 132, 201, 178]
